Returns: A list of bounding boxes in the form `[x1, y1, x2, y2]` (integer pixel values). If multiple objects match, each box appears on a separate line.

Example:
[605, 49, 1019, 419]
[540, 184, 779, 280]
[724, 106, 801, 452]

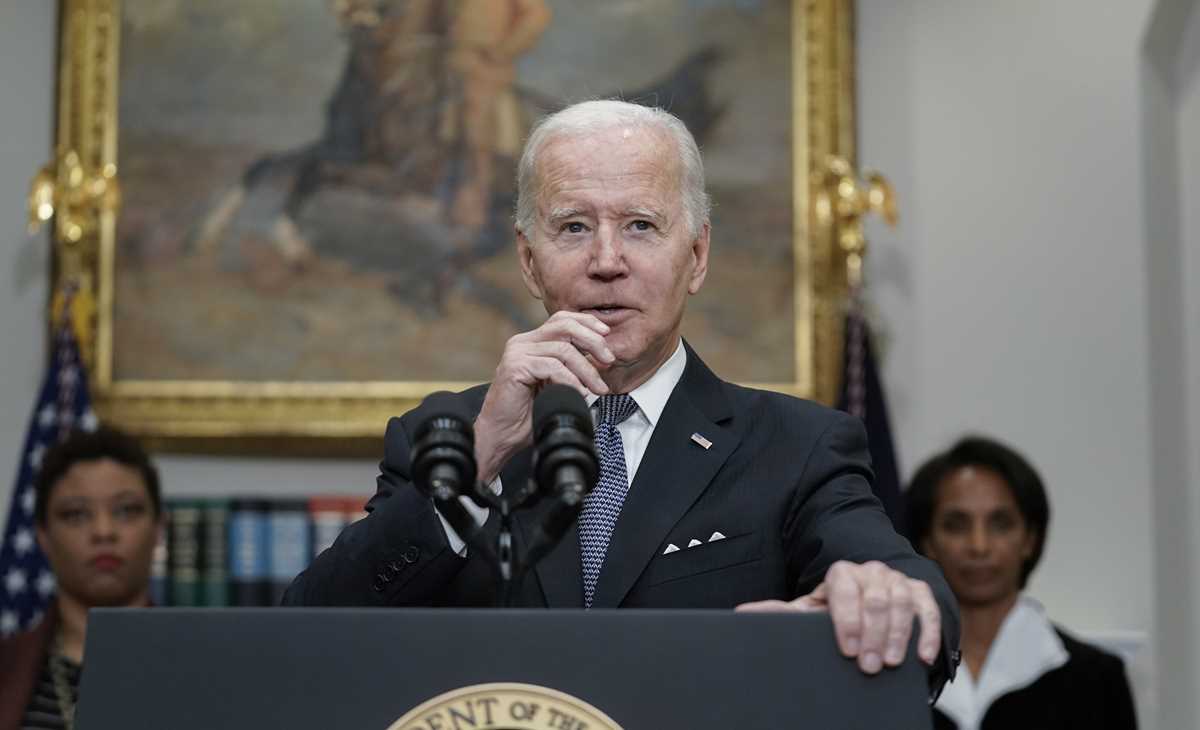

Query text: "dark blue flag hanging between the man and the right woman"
[838, 297, 905, 534]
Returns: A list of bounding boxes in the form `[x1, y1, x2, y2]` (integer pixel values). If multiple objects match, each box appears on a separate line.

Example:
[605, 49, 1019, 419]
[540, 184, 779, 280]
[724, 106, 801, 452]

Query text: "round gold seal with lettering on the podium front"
[388, 682, 622, 730]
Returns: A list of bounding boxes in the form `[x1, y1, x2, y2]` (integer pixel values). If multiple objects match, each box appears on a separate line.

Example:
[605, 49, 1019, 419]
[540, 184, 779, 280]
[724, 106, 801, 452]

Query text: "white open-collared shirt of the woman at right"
[935, 594, 1068, 730]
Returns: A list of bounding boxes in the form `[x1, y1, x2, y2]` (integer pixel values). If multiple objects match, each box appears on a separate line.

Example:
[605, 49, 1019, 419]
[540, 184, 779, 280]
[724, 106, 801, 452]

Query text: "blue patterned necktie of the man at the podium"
[580, 395, 637, 609]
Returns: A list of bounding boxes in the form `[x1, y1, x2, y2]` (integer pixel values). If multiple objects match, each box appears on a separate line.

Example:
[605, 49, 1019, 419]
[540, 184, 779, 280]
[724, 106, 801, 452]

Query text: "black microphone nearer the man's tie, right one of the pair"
[526, 384, 600, 566]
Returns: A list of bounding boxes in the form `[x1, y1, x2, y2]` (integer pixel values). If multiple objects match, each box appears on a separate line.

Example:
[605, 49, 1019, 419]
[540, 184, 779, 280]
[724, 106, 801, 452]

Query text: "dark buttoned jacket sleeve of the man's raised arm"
[283, 412, 466, 606]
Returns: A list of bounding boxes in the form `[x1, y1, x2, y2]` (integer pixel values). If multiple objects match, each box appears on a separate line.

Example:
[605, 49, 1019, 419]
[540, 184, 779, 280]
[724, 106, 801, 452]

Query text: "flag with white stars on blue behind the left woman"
[0, 317, 97, 636]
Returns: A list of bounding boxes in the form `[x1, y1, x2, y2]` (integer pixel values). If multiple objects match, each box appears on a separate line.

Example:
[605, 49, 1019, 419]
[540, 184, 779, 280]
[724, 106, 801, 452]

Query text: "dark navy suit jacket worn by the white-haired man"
[284, 347, 959, 687]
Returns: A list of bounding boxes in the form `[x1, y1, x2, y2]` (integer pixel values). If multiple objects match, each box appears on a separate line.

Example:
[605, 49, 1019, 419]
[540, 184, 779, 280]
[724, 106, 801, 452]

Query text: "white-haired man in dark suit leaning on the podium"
[284, 101, 959, 689]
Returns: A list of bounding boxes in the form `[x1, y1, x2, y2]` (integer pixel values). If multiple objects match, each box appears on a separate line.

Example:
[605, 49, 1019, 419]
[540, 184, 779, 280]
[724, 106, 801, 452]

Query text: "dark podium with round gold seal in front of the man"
[76, 609, 931, 730]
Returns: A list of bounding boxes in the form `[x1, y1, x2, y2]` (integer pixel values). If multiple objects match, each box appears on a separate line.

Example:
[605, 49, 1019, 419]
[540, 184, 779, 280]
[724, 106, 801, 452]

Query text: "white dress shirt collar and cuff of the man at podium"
[438, 339, 688, 556]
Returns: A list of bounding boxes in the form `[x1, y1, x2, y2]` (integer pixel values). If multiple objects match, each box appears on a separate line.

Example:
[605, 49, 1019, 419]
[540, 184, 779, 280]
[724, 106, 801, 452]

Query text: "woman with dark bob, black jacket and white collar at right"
[907, 437, 1136, 730]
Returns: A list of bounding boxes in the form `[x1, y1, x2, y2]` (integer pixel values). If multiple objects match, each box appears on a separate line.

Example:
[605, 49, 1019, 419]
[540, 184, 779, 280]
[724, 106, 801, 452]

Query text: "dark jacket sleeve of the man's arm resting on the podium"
[784, 412, 960, 698]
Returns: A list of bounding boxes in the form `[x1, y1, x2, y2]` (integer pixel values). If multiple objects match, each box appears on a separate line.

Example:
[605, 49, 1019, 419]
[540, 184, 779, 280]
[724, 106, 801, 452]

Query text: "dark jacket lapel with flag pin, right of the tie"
[590, 343, 740, 608]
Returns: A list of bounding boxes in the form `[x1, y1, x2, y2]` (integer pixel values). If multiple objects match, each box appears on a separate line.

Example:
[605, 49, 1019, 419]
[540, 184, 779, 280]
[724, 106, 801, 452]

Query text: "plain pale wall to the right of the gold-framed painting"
[858, 0, 1200, 729]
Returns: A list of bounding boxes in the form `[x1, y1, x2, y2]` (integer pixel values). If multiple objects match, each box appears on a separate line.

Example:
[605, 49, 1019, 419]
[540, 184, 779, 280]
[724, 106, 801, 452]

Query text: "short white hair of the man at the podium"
[516, 100, 710, 238]
